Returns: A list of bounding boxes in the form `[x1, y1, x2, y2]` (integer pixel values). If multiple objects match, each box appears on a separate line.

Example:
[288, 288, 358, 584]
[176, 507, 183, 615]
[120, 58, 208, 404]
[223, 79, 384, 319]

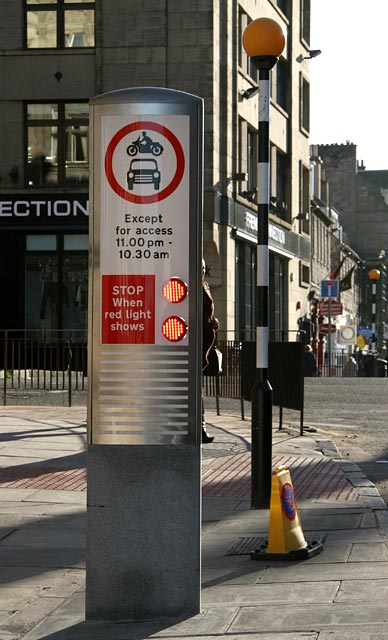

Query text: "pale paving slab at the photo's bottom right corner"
[228, 602, 388, 640]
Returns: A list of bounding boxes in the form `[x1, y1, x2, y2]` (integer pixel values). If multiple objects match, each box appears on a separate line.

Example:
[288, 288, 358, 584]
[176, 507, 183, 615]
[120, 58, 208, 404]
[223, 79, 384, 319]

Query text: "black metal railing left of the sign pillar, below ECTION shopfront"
[0, 329, 87, 407]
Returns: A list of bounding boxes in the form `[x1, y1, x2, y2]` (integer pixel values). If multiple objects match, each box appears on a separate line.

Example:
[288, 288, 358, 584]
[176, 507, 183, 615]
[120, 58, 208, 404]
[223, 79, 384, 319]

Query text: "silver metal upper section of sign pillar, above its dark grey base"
[88, 87, 203, 444]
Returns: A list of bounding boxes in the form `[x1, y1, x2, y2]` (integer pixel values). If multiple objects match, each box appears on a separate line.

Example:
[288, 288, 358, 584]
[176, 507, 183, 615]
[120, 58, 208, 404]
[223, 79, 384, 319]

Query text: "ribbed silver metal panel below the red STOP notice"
[94, 345, 189, 444]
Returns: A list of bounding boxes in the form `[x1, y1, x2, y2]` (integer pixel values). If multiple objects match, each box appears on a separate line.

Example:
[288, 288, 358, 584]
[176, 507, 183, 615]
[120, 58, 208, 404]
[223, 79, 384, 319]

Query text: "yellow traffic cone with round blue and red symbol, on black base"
[251, 467, 323, 560]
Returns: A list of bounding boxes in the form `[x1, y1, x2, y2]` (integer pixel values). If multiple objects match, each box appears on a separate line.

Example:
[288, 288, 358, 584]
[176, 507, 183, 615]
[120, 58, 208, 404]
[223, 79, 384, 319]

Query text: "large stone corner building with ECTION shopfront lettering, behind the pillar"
[0, 0, 316, 339]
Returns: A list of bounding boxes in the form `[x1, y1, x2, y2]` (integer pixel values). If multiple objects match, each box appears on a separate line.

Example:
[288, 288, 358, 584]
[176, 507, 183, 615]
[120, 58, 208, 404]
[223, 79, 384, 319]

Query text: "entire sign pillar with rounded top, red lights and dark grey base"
[86, 88, 203, 620]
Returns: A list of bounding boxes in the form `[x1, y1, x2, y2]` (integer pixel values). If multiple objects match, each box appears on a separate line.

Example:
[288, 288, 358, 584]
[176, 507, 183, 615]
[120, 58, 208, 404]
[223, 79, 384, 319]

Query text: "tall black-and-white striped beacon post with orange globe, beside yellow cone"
[243, 18, 285, 509]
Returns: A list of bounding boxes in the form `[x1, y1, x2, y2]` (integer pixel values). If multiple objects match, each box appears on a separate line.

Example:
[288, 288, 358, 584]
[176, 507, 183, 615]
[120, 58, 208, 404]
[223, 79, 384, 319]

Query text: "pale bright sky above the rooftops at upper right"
[309, 0, 388, 170]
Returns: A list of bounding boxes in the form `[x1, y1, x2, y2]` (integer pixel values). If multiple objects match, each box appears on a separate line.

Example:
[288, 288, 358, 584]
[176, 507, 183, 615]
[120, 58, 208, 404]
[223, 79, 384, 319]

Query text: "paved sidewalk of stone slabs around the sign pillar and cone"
[0, 406, 388, 640]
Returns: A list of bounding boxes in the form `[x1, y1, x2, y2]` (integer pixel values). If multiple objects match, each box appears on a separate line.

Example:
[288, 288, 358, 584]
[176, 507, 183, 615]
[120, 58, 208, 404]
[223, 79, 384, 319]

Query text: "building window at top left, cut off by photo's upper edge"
[25, 0, 95, 49]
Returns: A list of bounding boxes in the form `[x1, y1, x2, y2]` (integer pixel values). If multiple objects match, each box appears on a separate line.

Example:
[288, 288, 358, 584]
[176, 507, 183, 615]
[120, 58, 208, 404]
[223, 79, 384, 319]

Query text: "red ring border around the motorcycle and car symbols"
[105, 120, 185, 204]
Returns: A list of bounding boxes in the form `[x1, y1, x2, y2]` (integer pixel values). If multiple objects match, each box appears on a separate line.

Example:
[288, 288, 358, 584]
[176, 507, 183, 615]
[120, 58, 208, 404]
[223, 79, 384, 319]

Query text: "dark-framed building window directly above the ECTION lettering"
[26, 102, 89, 187]
